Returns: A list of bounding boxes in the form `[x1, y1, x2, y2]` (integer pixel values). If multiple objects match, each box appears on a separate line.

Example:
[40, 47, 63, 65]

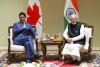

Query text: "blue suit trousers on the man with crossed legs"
[16, 36, 37, 58]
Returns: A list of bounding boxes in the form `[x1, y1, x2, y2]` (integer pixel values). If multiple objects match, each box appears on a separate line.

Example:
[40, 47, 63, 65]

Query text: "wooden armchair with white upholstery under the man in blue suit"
[8, 26, 38, 63]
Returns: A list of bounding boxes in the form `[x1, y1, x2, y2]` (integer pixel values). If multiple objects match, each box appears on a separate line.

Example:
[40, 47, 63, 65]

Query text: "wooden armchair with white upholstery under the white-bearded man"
[80, 23, 94, 62]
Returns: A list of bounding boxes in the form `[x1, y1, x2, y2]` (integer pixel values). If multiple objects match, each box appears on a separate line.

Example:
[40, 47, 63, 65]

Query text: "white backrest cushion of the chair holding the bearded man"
[84, 27, 92, 50]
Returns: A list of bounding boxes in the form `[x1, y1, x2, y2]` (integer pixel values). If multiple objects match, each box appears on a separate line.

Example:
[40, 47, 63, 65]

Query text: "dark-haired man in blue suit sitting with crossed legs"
[13, 12, 42, 63]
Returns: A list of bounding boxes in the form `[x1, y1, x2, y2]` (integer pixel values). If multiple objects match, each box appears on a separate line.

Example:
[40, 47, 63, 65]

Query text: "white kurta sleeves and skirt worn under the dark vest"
[62, 25, 84, 60]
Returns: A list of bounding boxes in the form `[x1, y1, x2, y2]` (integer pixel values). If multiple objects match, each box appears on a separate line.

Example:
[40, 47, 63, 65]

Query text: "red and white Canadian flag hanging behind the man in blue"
[27, 0, 42, 37]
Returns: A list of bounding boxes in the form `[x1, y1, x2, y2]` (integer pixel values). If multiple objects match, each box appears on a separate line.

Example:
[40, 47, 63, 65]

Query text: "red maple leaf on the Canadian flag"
[27, 3, 40, 26]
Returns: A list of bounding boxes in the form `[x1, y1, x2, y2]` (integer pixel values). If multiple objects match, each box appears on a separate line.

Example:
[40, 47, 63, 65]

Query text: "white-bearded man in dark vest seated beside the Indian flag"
[62, 14, 85, 65]
